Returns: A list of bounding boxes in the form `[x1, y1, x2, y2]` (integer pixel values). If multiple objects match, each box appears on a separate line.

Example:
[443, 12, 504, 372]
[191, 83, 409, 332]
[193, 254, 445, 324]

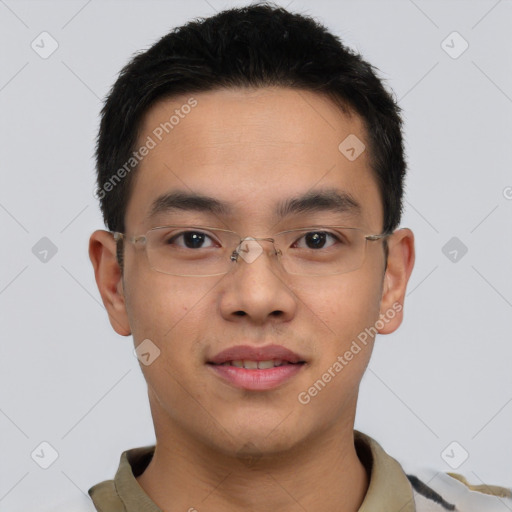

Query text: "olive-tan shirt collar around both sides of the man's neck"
[89, 430, 416, 512]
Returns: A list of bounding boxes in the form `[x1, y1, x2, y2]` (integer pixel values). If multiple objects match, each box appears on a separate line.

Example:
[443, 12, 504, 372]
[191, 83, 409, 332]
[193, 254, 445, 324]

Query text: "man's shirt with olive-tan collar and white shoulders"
[50, 431, 512, 512]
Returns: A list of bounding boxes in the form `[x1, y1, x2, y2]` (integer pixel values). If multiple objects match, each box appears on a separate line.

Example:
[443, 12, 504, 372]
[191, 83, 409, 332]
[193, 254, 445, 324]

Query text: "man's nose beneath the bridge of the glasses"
[220, 237, 297, 325]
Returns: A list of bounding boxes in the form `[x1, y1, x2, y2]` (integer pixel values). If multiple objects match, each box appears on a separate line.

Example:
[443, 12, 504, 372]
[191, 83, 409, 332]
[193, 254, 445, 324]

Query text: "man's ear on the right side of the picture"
[378, 228, 415, 334]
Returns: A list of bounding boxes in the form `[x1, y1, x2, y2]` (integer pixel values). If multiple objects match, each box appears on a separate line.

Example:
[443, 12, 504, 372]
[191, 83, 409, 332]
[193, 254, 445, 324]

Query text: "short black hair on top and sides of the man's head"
[96, 2, 406, 239]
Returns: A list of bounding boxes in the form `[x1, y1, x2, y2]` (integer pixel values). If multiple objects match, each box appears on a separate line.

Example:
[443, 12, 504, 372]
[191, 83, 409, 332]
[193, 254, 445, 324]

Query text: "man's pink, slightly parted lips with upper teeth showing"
[207, 345, 305, 391]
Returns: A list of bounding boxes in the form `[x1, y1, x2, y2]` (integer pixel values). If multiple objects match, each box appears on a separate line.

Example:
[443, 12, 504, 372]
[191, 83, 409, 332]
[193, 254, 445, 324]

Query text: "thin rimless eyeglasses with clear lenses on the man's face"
[112, 226, 391, 277]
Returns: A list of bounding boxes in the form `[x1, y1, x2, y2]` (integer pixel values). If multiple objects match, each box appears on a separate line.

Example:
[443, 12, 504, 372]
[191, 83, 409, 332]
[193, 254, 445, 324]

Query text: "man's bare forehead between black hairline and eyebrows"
[126, 88, 382, 230]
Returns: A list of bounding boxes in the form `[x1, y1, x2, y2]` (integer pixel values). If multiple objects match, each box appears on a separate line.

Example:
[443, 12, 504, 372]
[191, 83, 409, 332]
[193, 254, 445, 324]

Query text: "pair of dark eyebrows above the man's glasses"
[148, 189, 361, 219]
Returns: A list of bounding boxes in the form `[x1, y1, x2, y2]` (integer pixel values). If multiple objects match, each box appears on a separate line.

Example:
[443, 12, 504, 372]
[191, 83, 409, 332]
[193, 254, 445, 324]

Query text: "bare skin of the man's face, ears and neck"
[89, 88, 414, 512]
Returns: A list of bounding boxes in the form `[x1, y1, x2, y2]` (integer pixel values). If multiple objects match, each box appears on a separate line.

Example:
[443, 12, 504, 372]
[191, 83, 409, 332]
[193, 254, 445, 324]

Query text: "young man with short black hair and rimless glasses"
[78, 4, 508, 512]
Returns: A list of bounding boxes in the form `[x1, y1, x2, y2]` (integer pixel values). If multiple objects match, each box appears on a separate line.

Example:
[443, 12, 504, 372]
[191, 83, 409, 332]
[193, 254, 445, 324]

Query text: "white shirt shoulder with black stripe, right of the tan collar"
[407, 469, 512, 512]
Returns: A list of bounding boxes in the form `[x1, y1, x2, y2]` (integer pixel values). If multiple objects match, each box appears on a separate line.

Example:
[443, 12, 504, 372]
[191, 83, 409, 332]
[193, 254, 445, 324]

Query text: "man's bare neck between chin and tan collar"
[137, 412, 369, 512]
